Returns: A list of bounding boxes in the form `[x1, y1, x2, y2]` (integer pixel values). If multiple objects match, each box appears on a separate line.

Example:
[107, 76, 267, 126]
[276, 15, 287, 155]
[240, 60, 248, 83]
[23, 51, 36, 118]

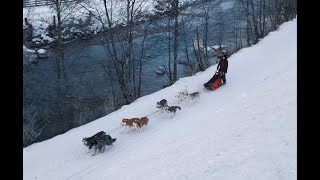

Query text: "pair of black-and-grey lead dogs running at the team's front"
[82, 131, 117, 155]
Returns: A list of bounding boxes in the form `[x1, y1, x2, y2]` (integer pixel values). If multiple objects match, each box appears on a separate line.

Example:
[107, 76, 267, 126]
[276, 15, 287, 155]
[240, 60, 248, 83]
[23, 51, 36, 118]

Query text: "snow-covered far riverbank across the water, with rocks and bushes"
[23, 0, 199, 49]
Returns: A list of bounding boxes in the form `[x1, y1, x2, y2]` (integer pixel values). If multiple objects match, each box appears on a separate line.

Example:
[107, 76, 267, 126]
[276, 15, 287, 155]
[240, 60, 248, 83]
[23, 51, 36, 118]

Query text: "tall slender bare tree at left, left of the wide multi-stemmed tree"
[48, 0, 88, 131]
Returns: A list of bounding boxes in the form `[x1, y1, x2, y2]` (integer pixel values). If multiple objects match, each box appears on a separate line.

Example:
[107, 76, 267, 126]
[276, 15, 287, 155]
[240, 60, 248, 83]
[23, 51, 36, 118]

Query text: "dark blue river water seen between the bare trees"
[24, 1, 245, 143]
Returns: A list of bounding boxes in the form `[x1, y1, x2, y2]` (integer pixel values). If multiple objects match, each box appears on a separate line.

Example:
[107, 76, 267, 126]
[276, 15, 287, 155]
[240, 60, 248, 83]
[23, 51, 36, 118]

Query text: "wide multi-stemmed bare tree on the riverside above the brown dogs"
[89, 0, 147, 105]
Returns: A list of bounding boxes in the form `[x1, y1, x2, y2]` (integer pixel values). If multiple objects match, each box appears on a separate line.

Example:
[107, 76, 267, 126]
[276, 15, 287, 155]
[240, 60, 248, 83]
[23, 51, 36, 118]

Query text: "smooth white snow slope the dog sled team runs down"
[23, 18, 297, 180]
